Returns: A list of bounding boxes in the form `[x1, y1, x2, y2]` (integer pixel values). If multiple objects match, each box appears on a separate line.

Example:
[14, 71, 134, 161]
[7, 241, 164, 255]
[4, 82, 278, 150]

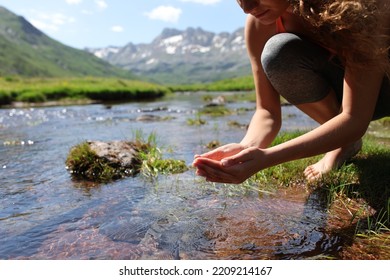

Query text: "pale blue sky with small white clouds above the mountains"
[0, 0, 246, 49]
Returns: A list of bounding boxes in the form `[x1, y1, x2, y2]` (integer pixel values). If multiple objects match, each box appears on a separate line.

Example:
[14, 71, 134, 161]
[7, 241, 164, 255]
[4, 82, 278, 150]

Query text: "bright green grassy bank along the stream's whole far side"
[0, 76, 254, 106]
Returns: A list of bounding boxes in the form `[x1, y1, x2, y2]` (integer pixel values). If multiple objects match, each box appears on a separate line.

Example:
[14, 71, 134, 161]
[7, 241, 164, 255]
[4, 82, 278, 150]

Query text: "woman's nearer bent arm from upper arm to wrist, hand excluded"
[259, 64, 384, 169]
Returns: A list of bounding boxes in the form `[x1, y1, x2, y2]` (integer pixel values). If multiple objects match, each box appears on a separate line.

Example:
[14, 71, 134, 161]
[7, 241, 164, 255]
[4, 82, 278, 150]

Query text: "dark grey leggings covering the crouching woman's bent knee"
[261, 33, 390, 119]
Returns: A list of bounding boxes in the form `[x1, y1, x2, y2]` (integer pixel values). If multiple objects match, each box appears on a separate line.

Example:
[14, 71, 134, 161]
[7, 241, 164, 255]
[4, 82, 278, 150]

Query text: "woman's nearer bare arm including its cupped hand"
[193, 64, 383, 184]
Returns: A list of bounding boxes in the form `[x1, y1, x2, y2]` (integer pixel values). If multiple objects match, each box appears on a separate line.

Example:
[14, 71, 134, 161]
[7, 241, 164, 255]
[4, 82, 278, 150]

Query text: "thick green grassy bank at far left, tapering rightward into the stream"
[0, 77, 169, 105]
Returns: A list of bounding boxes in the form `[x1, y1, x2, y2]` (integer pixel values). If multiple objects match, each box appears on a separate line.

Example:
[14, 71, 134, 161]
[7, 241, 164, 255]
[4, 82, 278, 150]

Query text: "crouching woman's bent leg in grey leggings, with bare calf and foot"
[261, 33, 361, 180]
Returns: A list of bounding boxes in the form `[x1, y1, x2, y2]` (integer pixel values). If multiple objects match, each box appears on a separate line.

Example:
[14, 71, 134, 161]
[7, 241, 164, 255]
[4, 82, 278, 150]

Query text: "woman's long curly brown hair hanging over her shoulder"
[288, 0, 390, 74]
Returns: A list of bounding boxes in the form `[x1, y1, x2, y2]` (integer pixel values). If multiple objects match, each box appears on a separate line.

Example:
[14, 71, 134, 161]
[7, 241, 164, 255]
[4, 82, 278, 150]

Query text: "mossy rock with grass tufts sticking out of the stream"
[66, 141, 188, 182]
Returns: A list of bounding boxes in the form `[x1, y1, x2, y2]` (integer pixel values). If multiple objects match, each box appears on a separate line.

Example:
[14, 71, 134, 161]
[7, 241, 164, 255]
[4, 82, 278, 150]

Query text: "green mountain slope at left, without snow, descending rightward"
[0, 6, 134, 78]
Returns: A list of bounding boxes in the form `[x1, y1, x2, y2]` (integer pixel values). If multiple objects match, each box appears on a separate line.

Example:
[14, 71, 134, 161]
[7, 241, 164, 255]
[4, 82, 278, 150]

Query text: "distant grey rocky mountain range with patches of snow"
[86, 28, 251, 84]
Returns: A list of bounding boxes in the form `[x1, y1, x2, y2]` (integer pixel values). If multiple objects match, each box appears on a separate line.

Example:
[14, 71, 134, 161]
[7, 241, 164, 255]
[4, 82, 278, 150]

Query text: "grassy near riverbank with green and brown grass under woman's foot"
[251, 130, 390, 260]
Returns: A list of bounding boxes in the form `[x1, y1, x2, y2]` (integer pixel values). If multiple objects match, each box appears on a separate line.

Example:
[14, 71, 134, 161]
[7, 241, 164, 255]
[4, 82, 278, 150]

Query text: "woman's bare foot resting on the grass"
[304, 139, 362, 181]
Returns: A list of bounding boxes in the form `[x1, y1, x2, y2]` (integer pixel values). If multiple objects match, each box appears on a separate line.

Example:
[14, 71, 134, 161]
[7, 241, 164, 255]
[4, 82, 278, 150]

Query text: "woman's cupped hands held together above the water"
[193, 147, 264, 184]
